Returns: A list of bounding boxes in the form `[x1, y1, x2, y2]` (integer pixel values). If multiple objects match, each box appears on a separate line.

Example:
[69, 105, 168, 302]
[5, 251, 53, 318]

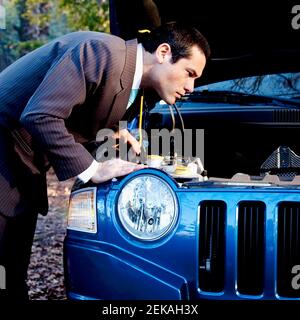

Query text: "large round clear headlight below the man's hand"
[118, 175, 178, 240]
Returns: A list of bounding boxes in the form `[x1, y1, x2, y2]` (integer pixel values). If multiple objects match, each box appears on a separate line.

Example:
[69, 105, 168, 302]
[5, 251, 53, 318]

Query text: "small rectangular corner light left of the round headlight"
[67, 188, 97, 233]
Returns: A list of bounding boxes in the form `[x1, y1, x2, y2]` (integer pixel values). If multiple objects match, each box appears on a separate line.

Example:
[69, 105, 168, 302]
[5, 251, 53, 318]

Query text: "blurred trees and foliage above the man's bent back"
[0, 0, 109, 71]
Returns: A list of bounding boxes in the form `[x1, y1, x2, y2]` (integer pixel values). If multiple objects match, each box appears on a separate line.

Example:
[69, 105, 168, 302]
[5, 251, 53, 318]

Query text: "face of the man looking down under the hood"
[153, 45, 206, 104]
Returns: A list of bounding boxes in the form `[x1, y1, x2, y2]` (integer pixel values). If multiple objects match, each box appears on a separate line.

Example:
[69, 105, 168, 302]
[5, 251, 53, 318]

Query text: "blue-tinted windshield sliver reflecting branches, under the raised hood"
[195, 72, 300, 99]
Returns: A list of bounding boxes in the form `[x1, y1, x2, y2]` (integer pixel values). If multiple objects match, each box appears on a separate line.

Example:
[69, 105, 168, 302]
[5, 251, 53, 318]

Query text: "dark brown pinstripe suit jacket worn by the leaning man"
[0, 31, 137, 216]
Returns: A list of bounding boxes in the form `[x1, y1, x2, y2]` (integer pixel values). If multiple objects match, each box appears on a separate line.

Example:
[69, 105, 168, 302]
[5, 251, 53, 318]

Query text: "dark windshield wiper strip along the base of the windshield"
[181, 90, 300, 108]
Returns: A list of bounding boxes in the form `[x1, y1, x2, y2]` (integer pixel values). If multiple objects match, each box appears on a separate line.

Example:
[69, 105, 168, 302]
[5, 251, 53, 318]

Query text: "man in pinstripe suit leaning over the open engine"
[0, 23, 210, 299]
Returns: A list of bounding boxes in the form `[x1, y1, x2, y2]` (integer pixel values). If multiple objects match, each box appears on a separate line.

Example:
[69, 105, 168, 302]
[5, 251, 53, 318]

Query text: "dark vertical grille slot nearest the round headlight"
[199, 201, 226, 292]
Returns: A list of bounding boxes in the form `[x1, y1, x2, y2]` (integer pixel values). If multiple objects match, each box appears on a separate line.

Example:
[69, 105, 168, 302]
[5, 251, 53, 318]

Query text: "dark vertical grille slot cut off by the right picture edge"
[277, 202, 300, 297]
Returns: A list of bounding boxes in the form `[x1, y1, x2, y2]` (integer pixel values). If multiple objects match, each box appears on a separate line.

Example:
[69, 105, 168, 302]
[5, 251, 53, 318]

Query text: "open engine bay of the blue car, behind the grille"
[134, 110, 300, 186]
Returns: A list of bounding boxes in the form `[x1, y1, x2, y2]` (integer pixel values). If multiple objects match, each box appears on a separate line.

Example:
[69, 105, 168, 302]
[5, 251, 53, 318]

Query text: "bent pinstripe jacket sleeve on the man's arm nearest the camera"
[20, 44, 101, 181]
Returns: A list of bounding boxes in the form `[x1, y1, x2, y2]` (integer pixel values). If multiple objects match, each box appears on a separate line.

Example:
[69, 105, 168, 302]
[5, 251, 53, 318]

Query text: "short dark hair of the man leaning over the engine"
[139, 22, 210, 63]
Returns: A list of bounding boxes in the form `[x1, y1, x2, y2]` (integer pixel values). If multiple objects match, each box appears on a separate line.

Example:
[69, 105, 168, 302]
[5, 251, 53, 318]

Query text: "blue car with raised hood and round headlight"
[64, 0, 300, 300]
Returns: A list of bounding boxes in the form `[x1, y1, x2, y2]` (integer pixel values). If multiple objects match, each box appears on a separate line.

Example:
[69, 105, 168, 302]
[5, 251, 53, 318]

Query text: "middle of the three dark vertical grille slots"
[237, 201, 266, 295]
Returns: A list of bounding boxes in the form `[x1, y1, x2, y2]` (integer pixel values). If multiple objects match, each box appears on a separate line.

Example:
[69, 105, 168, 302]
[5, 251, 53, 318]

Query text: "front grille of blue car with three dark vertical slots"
[198, 194, 300, 299]
